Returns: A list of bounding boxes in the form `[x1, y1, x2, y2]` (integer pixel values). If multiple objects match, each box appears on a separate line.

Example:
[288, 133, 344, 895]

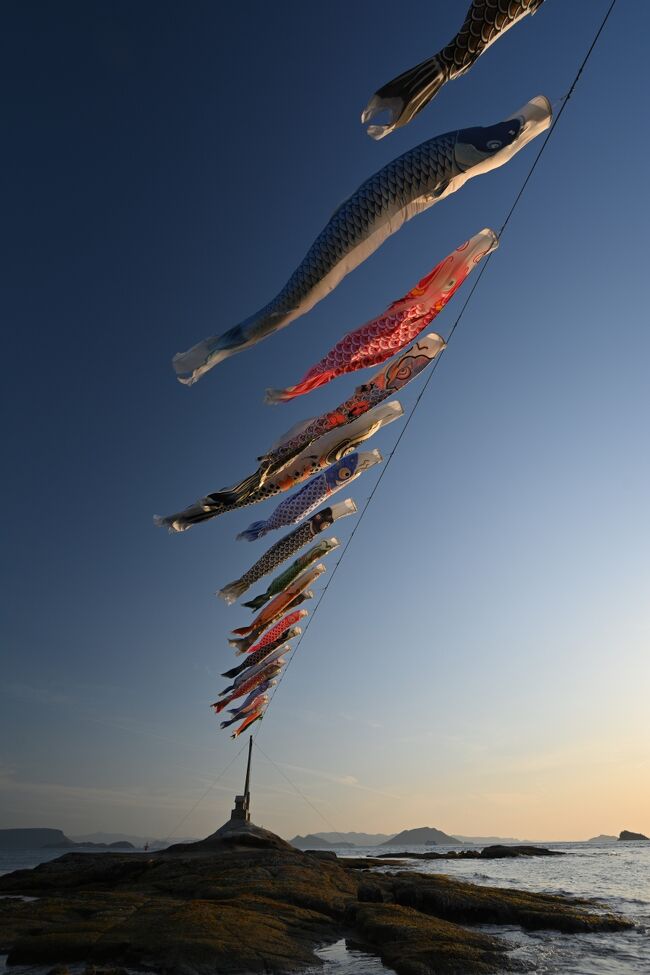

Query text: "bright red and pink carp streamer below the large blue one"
[266, 229, 499, 403]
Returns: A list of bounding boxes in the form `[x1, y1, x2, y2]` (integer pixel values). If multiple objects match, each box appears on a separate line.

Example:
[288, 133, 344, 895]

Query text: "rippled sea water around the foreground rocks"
[0, 842, 650, 975]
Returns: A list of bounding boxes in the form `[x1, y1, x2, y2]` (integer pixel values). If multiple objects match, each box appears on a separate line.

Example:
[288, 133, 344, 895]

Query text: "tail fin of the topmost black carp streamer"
[361, 55, 447, 139]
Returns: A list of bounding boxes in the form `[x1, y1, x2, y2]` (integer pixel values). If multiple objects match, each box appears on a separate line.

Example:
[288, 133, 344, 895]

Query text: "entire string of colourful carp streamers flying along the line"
[154, 0, 615, 738]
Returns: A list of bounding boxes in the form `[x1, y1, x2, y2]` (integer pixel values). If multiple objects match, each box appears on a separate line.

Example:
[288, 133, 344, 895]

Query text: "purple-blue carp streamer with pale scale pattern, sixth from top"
[237, 452, 380, 542]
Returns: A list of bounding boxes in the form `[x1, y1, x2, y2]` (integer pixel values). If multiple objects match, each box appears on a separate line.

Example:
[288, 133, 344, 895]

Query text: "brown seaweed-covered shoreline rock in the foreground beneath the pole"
[0, 824, 629, 975]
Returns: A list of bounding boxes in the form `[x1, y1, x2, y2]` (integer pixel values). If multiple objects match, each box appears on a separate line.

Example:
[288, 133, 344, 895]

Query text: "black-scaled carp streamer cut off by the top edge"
[361, 0, 544, 139]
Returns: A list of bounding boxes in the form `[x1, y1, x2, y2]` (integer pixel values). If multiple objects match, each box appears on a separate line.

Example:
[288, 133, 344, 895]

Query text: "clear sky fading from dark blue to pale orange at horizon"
[0, 0, 650, 839]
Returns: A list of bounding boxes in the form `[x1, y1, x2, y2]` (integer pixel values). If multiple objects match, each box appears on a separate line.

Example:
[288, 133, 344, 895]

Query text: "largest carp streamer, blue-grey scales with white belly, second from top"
[174, 95, 552, 385]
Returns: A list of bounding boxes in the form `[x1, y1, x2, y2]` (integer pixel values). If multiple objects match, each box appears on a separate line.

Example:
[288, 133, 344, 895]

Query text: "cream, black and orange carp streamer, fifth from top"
[154, 401, 404, 533]
